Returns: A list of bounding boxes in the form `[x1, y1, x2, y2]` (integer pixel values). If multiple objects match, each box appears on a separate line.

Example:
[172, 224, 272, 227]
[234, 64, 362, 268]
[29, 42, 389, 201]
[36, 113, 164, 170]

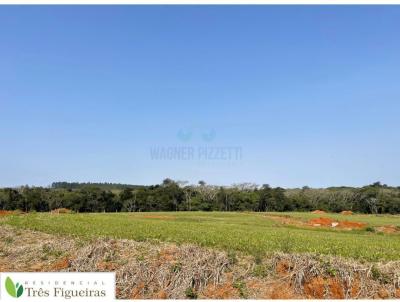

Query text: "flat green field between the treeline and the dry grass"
[0, 212, 400, 261]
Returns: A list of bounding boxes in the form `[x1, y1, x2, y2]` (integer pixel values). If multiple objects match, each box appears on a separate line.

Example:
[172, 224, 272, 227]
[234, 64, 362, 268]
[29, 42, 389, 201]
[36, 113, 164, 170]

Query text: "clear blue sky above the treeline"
[0, 6, 400, 187]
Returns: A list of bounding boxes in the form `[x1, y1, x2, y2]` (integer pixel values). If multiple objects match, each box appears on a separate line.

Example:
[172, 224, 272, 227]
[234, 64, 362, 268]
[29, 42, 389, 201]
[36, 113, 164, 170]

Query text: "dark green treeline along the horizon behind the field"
[0, 179, 400, 214]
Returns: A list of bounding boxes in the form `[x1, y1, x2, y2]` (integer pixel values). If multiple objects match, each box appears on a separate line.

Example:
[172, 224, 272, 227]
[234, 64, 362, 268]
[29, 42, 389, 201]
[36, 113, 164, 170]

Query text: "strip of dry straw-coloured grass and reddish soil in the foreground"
[0, 226, 400, 299]
